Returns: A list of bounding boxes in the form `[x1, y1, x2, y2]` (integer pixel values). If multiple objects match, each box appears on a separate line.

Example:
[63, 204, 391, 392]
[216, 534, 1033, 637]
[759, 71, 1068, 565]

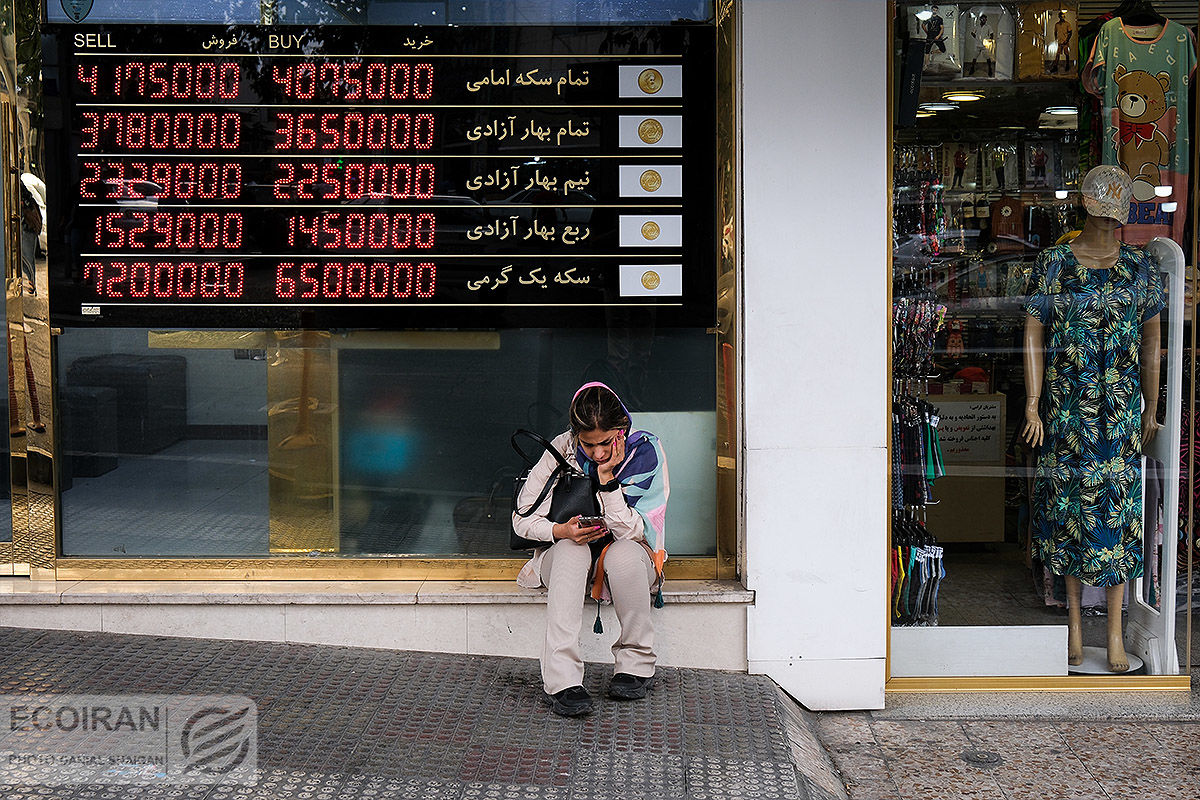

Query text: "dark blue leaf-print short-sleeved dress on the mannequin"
[1025, 245, 1164, 587]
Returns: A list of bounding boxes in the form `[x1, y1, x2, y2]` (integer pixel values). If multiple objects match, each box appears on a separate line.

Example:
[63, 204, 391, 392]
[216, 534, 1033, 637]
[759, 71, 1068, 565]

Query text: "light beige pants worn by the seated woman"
[541, 539, 655, 694]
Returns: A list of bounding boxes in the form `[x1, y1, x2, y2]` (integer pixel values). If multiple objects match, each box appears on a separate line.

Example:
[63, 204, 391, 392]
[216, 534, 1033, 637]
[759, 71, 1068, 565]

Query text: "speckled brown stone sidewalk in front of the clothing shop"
[817, 670, 1200, 800]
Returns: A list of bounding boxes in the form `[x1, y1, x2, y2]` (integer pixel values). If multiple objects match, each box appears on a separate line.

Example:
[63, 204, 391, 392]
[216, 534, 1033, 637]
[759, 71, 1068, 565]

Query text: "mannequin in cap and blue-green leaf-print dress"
[1021, 166, 1163, 673]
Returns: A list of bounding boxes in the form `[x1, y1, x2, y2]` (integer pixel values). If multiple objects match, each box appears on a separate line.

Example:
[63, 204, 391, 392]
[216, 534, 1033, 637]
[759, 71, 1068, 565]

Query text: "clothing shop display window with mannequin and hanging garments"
[889, 2, 1195, 676]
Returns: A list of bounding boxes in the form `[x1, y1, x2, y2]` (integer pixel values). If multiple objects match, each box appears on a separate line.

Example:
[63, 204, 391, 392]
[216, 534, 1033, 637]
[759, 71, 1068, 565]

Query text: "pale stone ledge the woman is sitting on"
[0, 577, 754, 606]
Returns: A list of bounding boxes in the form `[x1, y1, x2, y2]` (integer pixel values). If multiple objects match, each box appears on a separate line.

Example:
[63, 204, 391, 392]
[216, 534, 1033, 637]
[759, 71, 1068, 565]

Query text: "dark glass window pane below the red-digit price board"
[58, 327, 716, 557]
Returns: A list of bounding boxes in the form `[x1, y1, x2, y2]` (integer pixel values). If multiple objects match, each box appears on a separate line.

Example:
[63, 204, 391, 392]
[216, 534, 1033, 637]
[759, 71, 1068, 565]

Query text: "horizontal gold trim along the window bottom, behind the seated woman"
[55, 557, 716, 581]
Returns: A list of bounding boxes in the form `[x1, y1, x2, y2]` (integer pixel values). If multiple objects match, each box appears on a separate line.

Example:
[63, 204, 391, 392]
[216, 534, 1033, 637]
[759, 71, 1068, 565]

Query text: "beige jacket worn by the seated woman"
[512, 432, 646, 589]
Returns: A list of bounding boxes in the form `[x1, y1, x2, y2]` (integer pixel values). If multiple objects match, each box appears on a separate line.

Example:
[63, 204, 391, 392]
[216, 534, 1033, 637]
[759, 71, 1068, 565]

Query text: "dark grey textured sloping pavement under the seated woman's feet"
[0, 628, 841, 800]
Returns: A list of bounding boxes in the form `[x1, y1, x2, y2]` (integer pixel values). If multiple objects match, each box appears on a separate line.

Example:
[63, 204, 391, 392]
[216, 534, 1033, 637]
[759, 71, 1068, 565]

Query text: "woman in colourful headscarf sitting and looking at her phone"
[512, 383, 668, 716]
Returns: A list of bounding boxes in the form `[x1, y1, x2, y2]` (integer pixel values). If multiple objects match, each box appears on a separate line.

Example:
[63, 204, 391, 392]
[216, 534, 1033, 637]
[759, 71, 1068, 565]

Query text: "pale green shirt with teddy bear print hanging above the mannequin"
[1084, 17, 1196, 245]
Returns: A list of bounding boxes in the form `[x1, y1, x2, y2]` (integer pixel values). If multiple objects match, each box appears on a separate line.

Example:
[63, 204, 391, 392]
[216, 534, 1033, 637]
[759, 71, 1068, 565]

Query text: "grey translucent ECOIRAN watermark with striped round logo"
[0, 694, 258, 786]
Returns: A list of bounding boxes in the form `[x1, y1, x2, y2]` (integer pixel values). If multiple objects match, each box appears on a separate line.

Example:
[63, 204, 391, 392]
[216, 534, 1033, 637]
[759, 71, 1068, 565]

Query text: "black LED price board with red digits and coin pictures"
[43, 25, 718, 327]
